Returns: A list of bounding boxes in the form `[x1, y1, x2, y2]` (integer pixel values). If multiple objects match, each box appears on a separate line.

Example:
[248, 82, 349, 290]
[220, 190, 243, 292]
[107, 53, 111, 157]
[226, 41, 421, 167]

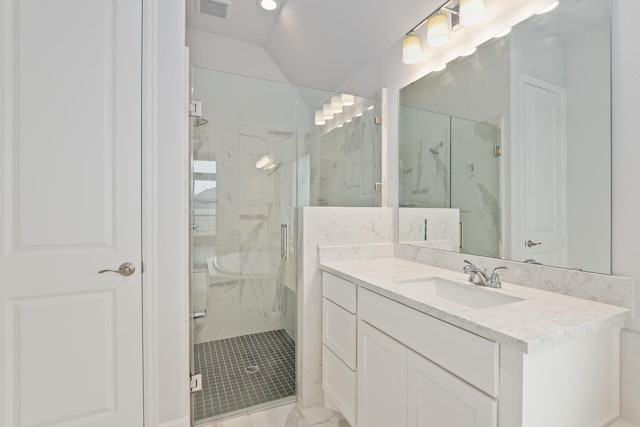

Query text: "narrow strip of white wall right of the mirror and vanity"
[612, 0, 640, 424]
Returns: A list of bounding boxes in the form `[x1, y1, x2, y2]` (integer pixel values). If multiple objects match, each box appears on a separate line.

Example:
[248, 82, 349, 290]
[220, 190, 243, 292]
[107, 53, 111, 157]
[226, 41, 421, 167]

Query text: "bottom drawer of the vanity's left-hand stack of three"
[322, 345, 357, 426]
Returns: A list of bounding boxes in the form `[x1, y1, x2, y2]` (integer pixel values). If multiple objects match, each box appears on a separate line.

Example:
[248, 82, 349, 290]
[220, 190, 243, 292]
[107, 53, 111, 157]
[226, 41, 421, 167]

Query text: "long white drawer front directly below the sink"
[358, 288, 499, 396]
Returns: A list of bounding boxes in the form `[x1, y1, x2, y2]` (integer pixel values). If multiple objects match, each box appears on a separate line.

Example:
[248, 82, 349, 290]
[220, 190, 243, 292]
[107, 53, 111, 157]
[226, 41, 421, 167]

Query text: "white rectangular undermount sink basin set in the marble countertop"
[394, 277, 523, 309]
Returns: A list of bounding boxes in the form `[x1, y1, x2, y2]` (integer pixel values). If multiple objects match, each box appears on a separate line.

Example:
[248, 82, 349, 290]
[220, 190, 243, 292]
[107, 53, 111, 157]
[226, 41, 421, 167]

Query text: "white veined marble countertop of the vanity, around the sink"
[320, 258, 630, 353]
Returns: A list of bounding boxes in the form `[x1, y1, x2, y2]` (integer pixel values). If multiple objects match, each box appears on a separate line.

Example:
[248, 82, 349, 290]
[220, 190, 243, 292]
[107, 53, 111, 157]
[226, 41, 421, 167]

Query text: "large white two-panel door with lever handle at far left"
[0, 0, 142, 427]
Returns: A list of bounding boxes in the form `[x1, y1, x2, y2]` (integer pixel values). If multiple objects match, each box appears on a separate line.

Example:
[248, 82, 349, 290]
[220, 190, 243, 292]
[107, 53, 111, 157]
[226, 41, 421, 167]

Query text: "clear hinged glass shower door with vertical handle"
[191, 68, 296, 424]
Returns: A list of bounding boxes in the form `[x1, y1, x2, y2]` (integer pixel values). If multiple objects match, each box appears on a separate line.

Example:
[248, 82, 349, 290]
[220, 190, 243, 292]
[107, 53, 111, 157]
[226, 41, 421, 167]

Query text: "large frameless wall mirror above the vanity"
[398, 0, 611, 274]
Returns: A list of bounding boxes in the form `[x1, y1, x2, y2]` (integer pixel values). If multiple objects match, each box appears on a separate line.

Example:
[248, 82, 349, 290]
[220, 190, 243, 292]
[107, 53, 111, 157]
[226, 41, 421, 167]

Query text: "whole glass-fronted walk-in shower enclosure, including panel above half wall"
[190, 68, 380, 424]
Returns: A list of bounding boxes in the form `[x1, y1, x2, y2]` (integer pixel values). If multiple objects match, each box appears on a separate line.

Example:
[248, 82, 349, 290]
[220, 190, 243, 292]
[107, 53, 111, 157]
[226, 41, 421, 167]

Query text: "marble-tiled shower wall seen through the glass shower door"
[192, 124, 295, 343]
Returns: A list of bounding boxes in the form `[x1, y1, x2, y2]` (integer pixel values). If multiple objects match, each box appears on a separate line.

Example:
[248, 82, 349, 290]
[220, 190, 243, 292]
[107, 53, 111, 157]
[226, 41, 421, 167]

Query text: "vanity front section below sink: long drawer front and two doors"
[358, 288, 498, 427]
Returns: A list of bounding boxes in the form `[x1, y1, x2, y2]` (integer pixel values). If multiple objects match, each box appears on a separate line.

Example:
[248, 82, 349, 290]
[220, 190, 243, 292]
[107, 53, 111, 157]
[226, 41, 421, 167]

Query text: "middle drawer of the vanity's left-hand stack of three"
[322, 298, 356, 369]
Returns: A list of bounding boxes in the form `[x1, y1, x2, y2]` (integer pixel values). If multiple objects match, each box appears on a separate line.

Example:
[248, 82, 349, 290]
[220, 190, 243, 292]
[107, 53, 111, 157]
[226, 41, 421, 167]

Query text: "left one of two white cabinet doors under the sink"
[358, 321, 407, 427]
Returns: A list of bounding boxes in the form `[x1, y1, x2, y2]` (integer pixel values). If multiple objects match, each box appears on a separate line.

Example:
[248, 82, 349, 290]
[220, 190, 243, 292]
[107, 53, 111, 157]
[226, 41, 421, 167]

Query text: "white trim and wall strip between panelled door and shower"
[148, 0, 190, 427]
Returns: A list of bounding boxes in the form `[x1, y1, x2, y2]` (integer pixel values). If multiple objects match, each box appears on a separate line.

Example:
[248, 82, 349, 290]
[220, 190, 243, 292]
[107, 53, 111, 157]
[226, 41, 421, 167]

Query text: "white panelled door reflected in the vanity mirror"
[522, 82, 567, 266]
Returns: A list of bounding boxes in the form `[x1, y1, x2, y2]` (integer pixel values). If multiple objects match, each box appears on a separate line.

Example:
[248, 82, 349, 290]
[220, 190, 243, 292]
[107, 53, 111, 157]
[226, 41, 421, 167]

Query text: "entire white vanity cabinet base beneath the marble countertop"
[322, 272, 622, 427]
